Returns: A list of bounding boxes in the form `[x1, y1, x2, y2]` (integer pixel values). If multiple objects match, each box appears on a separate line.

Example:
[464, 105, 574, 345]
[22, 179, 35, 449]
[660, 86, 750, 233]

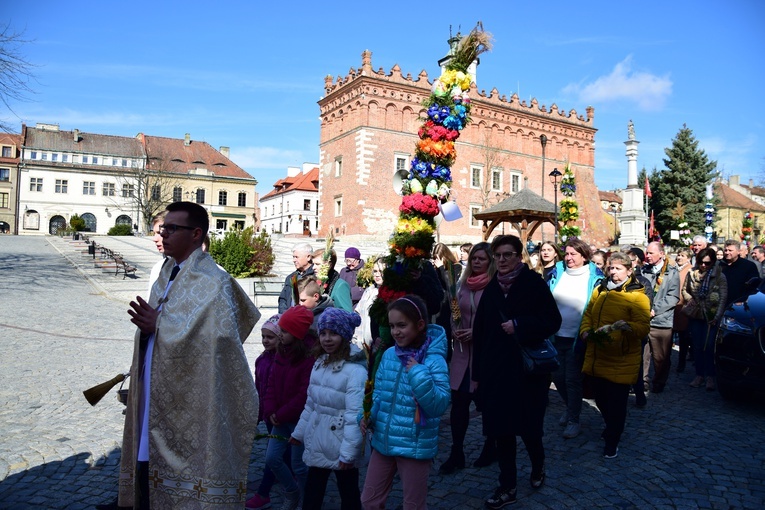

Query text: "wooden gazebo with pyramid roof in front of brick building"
[474, 188, 555, 246]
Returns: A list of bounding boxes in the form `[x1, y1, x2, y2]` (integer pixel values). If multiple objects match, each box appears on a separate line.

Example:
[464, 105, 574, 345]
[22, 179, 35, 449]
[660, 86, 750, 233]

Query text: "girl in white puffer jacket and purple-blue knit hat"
[290, 308, 367, 510]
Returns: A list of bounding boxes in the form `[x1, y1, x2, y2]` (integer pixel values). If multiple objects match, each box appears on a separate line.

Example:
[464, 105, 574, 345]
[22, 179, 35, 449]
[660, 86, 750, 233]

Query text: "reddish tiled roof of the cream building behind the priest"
[136, 133, 254, 179]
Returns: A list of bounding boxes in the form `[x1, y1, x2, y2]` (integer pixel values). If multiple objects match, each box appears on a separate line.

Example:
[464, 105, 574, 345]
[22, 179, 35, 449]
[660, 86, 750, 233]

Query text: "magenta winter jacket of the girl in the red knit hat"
[263, 338, 316, 423]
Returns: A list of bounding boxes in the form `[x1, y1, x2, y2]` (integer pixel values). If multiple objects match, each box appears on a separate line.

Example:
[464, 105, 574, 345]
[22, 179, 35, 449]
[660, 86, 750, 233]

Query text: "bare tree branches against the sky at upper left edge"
[0, 25, 35, 133]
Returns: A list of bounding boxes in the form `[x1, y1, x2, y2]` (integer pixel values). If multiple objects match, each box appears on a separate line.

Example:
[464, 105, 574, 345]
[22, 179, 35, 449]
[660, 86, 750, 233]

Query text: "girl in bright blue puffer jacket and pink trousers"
[360, 295, 450, 510]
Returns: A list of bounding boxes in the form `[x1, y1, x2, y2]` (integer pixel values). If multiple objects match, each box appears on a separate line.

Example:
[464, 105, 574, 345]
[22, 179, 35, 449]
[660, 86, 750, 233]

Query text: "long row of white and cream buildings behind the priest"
[17, 124, 257, 234]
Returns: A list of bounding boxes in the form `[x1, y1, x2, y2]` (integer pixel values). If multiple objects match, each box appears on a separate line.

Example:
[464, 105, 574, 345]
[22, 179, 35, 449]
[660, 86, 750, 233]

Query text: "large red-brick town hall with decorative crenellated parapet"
[319, 47, 612, 242]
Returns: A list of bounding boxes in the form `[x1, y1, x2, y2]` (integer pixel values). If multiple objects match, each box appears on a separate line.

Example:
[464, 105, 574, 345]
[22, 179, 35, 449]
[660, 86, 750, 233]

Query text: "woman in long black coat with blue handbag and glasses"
[472, 236, 561, 508]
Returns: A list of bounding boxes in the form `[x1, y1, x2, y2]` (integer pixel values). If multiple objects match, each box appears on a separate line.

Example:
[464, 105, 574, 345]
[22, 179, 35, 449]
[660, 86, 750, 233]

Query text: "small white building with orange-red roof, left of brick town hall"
[259, 163, 319, 236]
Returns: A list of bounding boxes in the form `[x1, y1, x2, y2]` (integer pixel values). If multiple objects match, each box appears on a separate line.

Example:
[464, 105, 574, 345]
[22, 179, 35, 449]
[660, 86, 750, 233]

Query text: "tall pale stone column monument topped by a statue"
[617, 120, 648, 246]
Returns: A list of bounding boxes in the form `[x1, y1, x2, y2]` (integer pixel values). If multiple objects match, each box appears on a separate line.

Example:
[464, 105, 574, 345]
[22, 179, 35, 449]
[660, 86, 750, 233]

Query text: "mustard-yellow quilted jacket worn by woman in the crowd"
[579, 276, 651, 384]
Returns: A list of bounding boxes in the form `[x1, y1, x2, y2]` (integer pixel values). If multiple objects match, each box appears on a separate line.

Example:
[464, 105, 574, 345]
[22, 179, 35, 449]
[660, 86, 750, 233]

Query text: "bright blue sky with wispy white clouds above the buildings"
[0, 0, 765, 195]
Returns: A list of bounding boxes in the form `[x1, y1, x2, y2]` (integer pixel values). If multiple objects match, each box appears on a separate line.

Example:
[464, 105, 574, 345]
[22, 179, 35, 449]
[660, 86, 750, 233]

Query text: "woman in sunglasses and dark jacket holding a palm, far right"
[683, 248, 728, 391]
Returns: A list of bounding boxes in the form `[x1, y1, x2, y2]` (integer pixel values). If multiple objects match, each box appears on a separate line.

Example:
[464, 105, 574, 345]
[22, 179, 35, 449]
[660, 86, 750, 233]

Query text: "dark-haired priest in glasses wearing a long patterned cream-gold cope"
[119, 202, 260, 509]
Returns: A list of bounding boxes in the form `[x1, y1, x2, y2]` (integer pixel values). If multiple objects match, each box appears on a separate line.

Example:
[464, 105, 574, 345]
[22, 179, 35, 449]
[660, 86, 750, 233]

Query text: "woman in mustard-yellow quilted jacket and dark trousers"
[579, 253, 651, 459]
